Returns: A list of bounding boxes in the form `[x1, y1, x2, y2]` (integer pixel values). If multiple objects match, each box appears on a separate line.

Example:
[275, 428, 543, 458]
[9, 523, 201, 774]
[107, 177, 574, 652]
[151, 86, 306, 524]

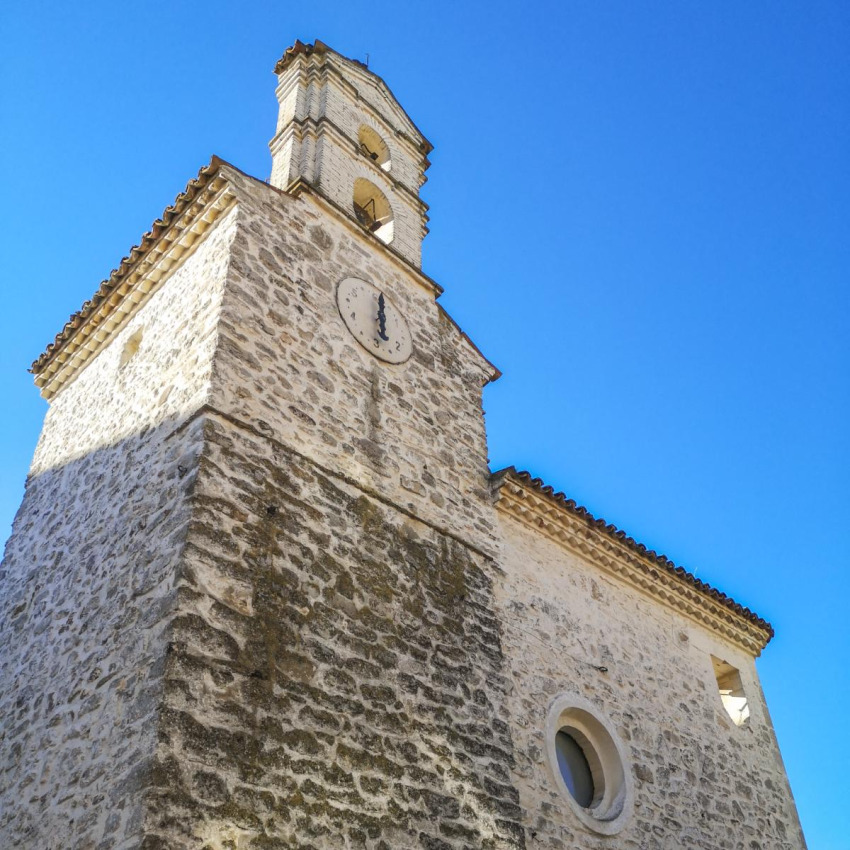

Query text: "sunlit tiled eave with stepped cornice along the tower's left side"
[30, 157, 235, 401]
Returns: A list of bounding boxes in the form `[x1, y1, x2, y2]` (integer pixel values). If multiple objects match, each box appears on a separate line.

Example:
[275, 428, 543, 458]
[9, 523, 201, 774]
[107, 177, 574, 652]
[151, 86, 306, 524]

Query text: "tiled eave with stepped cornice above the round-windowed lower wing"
[492, 469, 773, 657]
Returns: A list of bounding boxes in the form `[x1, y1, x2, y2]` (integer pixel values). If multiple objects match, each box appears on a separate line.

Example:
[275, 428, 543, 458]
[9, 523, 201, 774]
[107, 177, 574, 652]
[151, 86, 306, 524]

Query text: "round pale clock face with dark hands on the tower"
[336, 277, 413, 363]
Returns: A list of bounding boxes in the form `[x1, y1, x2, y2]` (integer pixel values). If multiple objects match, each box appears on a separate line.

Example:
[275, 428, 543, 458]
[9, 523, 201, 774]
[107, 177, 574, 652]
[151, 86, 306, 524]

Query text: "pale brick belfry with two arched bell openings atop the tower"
[269, 41, 432, 267]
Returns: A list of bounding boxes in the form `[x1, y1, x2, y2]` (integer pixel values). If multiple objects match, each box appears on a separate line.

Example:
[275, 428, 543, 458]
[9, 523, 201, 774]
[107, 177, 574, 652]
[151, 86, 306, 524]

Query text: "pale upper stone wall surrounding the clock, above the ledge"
[211, 167, 494, 549]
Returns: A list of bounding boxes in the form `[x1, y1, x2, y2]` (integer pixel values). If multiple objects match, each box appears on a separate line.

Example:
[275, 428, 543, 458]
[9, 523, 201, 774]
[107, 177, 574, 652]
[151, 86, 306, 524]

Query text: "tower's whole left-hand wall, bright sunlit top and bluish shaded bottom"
[0, 202, 235, 850]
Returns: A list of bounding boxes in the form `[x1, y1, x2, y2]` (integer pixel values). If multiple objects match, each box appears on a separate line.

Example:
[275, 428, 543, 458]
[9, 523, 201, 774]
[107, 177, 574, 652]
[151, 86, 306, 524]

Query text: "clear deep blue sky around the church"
[0, 0, 850, 850]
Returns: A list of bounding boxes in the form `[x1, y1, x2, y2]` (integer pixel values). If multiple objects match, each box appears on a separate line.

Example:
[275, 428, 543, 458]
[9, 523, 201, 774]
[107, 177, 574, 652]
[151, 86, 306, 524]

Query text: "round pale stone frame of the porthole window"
[545, 693, 634, 835]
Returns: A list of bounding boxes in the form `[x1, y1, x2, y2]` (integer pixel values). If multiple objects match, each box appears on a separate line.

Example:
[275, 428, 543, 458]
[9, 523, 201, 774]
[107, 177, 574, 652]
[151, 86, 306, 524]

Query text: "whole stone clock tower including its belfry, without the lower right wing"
[0, 36, 510, 850]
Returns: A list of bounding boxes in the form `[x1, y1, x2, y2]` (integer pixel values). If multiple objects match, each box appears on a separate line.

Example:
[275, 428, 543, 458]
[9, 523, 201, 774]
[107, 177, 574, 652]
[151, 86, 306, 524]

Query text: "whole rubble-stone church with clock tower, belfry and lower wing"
[0, 41, 805, 850]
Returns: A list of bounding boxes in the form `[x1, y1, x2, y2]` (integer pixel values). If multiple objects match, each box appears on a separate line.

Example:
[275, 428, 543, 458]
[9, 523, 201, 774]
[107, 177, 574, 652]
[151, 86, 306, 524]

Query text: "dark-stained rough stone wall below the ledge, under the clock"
[144, 414, 524, 850]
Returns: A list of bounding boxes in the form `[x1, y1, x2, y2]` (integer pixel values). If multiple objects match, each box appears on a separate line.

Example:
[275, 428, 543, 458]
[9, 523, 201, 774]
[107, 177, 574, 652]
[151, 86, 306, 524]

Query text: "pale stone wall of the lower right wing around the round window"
[495, 515, 805, 850]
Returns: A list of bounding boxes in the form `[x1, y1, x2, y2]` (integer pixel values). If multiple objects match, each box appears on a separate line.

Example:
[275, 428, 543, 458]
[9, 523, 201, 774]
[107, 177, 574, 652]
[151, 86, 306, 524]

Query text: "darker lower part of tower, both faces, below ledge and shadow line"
[0, 411, 524, 850]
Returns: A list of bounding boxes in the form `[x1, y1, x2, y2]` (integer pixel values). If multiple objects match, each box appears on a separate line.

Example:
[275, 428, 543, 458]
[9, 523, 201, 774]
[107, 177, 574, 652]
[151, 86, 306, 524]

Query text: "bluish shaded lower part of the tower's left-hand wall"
[0, 408, 202, 850]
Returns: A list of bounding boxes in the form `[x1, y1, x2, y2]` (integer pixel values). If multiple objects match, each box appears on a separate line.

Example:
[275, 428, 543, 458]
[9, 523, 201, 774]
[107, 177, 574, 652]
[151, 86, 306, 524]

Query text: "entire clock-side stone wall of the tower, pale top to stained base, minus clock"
[137, 164, 523, 850]
